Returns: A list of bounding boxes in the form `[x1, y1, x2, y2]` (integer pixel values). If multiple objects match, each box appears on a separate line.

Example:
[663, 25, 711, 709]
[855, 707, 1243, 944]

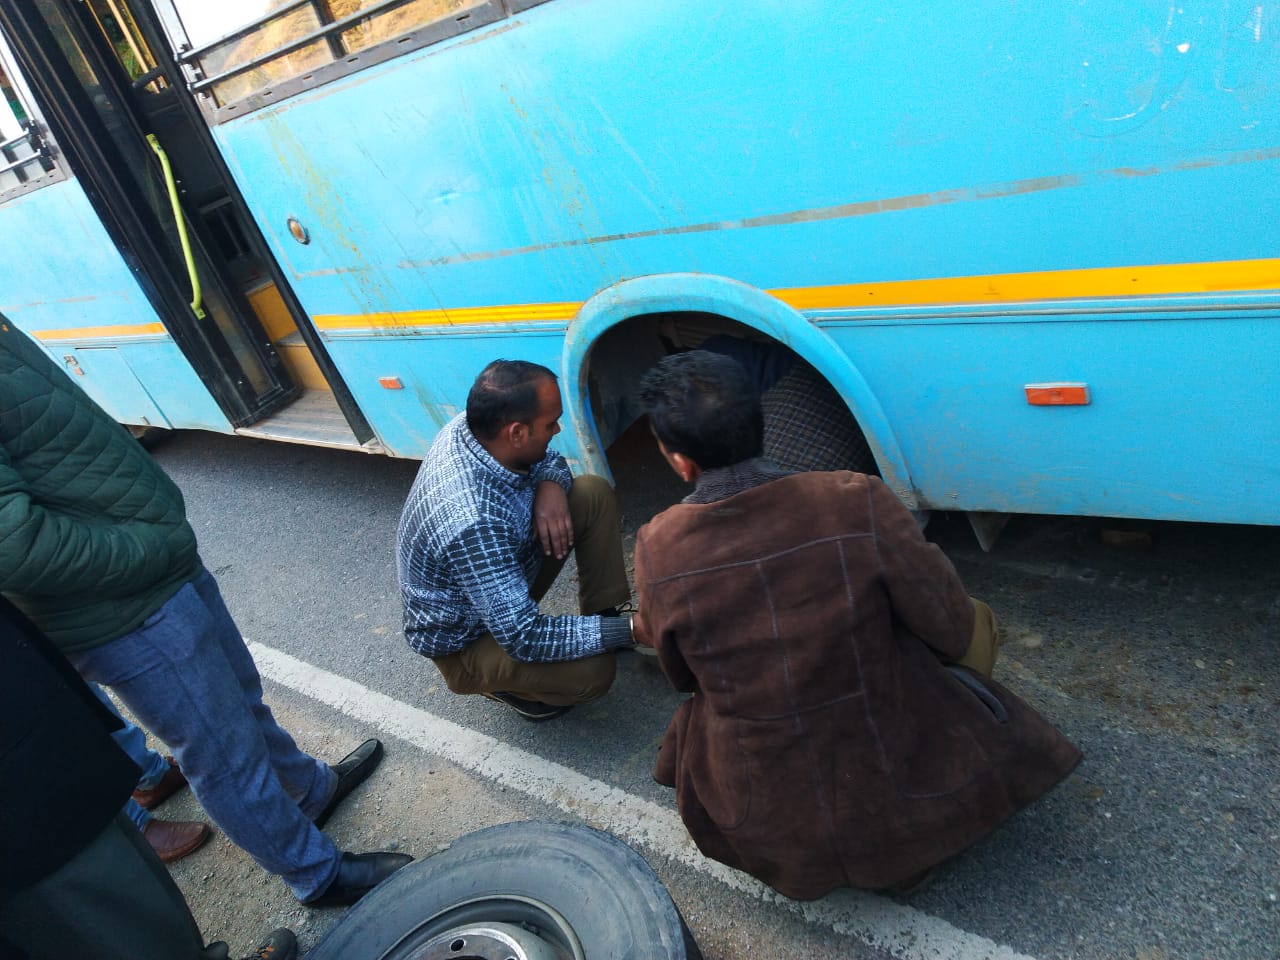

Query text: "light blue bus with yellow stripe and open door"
[0, 0, 1280, 542]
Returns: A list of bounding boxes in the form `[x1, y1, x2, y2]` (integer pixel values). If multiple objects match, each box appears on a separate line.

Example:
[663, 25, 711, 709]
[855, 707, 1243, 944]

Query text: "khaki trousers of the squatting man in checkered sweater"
[434, 475, 631, 707]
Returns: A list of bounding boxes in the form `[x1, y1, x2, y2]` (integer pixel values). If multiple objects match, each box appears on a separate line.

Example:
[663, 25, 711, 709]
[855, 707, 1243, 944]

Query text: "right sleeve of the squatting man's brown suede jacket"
[868, 477, 973, 662]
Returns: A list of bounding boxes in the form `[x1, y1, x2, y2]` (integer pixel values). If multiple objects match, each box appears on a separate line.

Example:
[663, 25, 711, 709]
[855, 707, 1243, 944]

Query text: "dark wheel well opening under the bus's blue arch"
[586, 312, 879, 476]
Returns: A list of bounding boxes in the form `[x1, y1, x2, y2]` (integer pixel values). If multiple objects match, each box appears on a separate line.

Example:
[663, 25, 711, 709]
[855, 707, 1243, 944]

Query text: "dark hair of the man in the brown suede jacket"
[640, 349, 764, 470]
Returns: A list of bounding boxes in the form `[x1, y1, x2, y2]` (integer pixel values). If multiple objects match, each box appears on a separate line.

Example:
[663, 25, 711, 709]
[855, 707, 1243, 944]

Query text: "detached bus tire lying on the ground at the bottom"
[307, 820, 701, 960]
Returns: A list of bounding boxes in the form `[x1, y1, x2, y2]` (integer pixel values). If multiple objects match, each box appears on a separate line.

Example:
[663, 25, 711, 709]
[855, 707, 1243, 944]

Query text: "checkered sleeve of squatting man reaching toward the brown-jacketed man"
[447, 521, 631, 663]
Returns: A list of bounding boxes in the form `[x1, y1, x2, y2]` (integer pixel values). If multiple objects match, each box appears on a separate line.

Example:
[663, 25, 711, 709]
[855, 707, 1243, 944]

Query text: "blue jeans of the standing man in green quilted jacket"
[69, 571, 342, 901]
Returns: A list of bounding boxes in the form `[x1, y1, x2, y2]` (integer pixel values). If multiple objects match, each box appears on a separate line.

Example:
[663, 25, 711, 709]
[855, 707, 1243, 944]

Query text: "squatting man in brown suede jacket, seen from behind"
[635, 351, 1080, 900]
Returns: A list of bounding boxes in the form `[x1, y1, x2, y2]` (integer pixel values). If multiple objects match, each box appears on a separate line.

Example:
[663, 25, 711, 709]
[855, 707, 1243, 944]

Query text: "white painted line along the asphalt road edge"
[250, 644, 1033, 960]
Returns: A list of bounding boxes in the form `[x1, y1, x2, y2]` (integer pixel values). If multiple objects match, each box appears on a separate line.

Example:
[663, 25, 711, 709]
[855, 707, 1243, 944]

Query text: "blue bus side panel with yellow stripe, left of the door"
[0, 179, 232, 433]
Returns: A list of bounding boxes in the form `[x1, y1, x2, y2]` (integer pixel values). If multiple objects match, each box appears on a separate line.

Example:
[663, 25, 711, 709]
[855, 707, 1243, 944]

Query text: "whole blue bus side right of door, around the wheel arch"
[197, 0, 1280, 522]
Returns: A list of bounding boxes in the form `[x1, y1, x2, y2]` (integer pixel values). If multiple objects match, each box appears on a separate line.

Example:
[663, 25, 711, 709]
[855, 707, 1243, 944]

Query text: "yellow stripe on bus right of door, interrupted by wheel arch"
[315, 259, 1280, 330]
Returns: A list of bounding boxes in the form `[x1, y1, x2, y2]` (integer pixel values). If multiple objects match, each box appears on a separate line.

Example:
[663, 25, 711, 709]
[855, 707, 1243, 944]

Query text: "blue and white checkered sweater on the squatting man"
[396, 413, 619, 663]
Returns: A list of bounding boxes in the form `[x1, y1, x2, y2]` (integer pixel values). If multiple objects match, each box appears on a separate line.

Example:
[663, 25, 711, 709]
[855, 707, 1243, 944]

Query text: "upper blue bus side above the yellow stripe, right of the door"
[216, 0, 1280, 308]
